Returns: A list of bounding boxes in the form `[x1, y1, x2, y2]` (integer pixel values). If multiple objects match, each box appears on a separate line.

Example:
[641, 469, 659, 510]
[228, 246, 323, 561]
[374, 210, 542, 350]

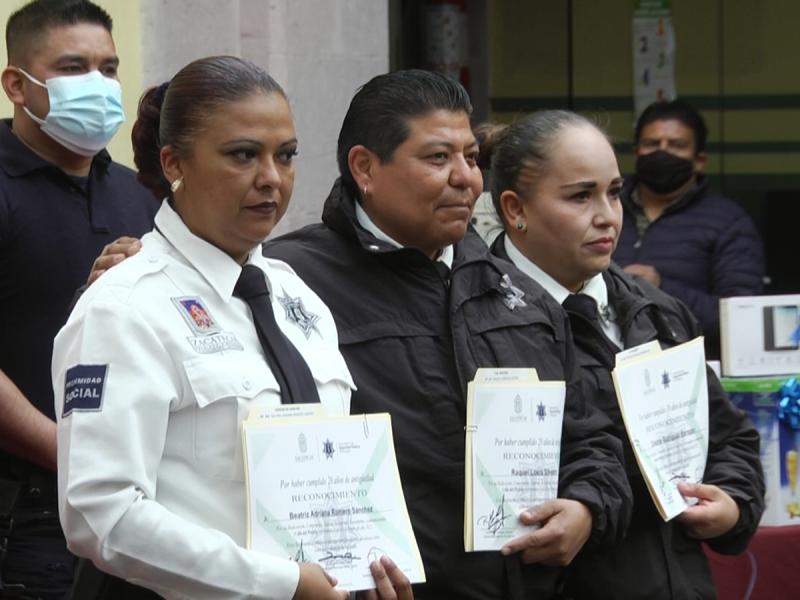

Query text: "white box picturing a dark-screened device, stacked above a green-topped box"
[719, 294, 800, 377]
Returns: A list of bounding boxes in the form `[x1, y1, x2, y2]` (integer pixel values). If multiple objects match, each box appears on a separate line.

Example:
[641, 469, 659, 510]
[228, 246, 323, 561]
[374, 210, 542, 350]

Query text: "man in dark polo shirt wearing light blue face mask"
[0, 0, 156, 600]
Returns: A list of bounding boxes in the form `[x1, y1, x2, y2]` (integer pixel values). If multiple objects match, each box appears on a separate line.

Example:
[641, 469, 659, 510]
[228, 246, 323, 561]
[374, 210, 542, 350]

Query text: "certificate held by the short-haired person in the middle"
[464, 369, 566, 552]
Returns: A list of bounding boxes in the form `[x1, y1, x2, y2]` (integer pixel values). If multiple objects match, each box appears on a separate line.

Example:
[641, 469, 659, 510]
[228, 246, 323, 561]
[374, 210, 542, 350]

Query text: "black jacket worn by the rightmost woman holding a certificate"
[492, 235, 764, 600]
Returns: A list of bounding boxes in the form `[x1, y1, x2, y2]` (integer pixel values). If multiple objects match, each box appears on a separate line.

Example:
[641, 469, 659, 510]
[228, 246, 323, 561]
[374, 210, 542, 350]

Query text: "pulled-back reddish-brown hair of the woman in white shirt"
[131, 56, 286, 200]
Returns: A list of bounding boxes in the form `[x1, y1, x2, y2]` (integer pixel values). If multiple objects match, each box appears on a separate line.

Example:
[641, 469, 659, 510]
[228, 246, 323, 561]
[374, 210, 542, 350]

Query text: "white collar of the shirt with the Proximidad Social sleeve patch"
[155, 200, 270, 302]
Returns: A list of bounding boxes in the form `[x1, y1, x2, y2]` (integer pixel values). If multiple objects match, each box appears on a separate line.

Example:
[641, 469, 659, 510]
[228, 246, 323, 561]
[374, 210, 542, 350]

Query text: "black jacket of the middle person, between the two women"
[265, 182, 630, 600]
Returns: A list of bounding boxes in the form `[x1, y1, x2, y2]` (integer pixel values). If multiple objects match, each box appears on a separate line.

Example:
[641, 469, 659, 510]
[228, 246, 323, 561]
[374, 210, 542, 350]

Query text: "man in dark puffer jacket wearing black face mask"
[613, 100, 765, 359]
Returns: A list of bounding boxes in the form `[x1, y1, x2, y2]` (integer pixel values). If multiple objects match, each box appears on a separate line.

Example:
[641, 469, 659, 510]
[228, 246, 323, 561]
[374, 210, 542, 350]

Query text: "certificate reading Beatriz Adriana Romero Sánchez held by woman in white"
[242, 414, 425, 591]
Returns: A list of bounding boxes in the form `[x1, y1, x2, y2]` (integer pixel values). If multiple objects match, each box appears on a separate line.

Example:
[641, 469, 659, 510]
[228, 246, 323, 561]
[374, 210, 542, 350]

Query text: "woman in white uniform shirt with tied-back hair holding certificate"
[53, 57, 402, 600]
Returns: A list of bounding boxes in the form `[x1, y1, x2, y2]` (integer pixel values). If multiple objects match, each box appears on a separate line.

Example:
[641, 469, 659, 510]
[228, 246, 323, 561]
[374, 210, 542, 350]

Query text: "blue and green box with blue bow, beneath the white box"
[720, 377, 800, 526]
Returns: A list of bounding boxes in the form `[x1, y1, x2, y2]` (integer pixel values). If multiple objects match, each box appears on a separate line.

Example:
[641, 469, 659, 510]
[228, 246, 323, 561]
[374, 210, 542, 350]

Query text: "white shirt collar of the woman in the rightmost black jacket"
[504, 236, 625, 350]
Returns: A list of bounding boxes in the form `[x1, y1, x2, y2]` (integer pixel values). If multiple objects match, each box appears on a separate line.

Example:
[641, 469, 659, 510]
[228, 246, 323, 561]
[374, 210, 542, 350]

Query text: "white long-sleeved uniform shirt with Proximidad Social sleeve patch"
[53, 202, 353, 600]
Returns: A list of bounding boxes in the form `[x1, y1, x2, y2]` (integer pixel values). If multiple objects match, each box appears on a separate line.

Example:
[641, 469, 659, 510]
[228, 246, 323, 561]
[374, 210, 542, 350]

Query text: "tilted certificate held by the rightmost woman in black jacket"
[613, 337, 708, 521]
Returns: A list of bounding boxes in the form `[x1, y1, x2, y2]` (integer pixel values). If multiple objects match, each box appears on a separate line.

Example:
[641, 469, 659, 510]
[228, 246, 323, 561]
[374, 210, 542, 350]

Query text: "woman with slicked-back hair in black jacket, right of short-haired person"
[481, 111, 764, 600]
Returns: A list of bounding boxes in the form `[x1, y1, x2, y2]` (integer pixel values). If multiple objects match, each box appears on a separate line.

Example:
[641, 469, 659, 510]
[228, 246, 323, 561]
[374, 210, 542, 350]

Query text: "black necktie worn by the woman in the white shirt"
[233, 265, 319, 404]
